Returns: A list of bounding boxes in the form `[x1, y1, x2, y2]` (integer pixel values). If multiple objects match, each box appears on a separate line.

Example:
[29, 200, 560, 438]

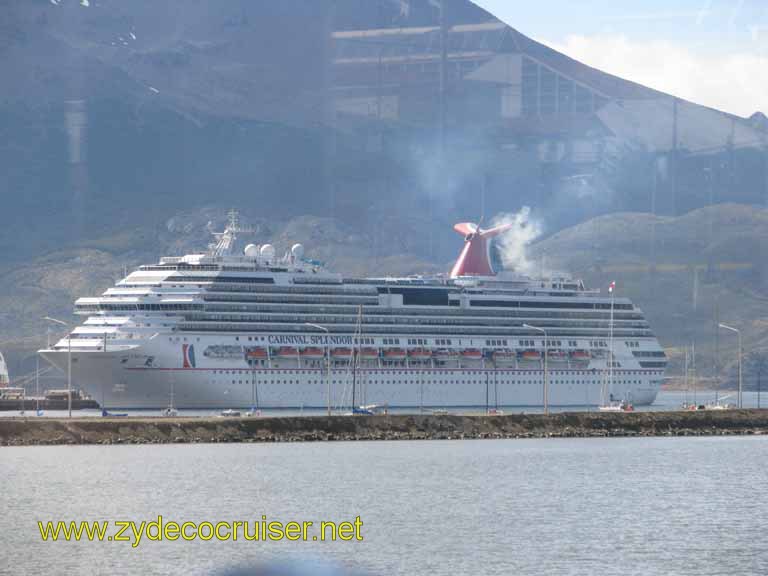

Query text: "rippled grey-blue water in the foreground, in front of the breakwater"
[0, 437, 768, 576]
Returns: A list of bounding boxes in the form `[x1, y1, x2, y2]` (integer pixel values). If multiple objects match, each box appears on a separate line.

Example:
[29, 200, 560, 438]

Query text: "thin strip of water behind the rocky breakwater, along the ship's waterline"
[0, 390, 768, 418]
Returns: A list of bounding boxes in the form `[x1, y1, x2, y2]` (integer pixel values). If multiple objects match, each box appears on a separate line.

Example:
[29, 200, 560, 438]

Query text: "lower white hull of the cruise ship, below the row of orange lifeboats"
[43, 351, 661, 409]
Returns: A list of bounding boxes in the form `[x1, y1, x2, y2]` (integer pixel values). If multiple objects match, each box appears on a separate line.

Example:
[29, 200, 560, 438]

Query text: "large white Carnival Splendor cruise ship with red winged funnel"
[40, 212, 666, 410]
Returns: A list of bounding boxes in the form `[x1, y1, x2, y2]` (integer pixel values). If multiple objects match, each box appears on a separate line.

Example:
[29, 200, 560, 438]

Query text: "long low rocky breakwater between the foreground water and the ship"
[0, 410, 768, 446]
